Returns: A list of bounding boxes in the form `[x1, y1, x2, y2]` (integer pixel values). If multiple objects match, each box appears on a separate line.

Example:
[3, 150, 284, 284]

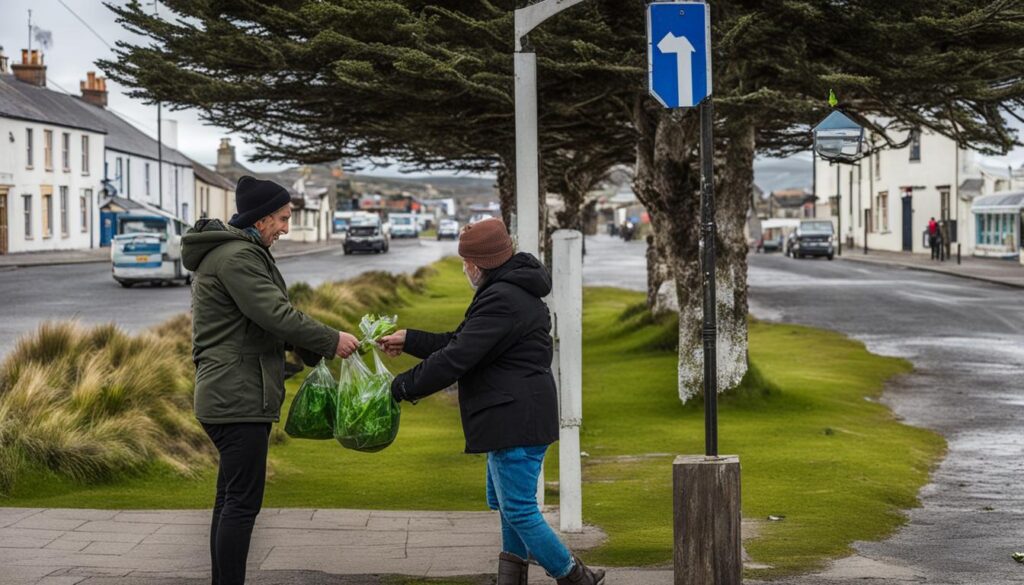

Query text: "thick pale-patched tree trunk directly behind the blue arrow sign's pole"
[634, 99, 754, 403]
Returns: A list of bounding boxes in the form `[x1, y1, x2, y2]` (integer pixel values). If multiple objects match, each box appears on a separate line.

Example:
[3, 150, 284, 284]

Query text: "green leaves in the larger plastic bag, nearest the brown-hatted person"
[334, 352, 401, 453]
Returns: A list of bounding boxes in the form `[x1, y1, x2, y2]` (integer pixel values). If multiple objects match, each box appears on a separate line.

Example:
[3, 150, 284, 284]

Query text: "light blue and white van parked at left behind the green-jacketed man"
[111, 212, 191, 288]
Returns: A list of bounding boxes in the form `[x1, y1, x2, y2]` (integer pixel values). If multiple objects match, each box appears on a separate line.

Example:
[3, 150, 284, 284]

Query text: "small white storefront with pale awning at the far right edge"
[971, 191, 1024, 258]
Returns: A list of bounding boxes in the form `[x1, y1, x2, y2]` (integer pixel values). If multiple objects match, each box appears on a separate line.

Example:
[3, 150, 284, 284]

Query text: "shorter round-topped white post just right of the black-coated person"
[551, 229, 583, 533]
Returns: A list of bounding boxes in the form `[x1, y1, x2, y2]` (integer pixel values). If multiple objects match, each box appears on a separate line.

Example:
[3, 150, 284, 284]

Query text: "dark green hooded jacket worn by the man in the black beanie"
[181, 219, 338, 424]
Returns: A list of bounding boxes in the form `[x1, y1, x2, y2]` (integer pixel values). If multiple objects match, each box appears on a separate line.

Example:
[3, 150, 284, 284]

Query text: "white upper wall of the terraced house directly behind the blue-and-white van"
[105, 149, 198, 223]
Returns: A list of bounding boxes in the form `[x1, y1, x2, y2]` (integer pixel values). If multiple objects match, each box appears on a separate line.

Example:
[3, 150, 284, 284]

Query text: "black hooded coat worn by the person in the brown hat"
[391, 253, 558, 453]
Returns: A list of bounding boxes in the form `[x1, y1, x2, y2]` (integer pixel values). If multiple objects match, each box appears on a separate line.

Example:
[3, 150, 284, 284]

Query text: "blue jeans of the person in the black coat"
[487, 446, 573, 579]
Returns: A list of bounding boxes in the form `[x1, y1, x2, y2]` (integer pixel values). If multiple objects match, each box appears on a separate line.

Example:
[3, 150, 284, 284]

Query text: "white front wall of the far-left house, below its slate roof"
[0, 118, 103, 253]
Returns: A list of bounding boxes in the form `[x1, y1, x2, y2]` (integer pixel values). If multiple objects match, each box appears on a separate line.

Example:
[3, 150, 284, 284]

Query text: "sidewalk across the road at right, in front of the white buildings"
[841, 248, 1024, 288]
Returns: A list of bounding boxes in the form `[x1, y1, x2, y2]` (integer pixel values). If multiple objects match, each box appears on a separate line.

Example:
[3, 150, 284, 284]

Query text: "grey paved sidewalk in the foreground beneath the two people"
[0, 508, 655, 585]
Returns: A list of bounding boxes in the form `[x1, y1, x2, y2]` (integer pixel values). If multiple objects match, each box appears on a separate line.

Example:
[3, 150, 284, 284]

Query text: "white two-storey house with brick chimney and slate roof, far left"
[0, 51, 105, 254]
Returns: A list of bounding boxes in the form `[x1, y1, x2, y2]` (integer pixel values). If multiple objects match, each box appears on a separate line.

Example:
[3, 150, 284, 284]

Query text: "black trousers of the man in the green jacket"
[203, 422, 270, 585]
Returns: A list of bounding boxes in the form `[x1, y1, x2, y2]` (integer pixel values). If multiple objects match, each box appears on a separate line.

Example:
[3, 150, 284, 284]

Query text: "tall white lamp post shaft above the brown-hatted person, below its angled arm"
[515, 52, 541, 256]
